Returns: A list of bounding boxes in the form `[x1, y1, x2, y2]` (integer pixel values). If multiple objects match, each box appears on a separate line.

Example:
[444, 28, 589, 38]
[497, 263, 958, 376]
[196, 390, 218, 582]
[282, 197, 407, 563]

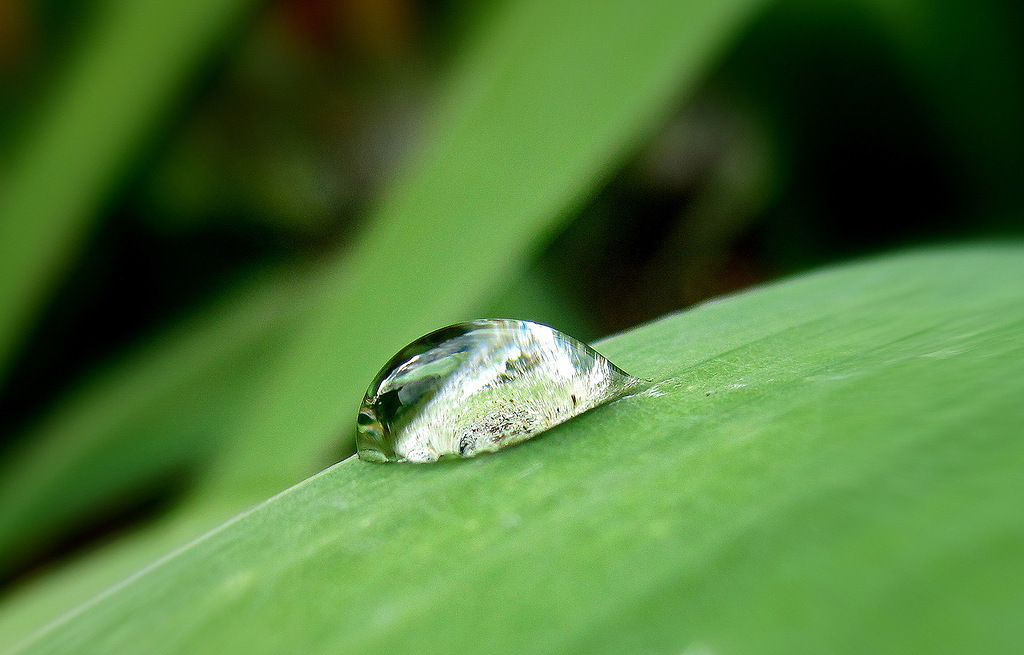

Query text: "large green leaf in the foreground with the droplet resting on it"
[17, 246, 1024, 654]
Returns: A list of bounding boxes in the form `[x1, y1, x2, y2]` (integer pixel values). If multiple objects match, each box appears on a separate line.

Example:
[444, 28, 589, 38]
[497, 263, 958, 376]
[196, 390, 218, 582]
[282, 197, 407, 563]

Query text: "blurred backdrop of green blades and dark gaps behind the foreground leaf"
[0, 0, 1024, 646]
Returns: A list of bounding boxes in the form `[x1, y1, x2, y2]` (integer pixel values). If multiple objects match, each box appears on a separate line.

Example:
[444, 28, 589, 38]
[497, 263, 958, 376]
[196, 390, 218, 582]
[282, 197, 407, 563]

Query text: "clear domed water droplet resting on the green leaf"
[356, 318, 641, 463]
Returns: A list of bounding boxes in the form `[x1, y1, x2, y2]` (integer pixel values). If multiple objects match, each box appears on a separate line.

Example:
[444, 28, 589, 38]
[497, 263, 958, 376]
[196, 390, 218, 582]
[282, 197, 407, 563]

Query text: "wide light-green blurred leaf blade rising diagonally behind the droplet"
[205, 0, 759, 503]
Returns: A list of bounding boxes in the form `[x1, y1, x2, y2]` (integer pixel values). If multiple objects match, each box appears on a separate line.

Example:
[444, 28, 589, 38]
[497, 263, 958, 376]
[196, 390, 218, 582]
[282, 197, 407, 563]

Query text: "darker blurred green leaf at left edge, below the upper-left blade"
[0, 270, 307, 576]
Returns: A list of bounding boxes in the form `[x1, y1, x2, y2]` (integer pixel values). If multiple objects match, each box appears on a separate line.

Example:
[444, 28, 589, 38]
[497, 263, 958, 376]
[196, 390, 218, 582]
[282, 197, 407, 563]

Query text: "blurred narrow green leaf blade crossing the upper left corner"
[0, 0, 260, 379]
